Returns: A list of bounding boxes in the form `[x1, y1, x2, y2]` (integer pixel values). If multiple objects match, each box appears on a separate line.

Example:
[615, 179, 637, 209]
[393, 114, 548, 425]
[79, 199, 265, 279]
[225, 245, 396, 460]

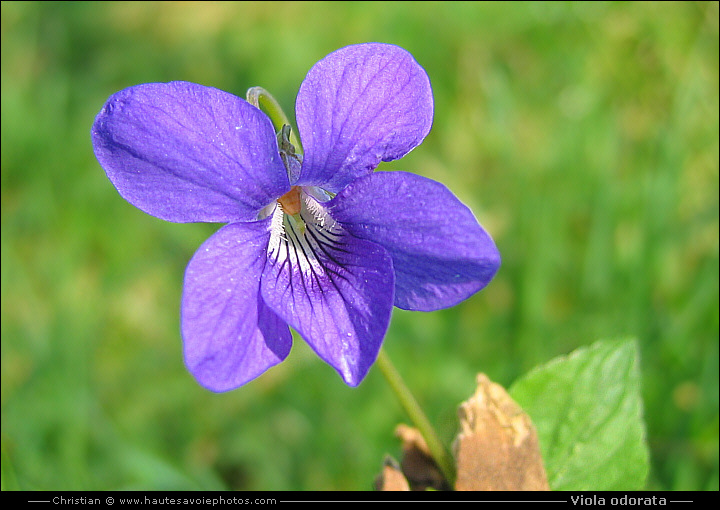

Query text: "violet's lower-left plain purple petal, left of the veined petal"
[181, 219, 292, 391]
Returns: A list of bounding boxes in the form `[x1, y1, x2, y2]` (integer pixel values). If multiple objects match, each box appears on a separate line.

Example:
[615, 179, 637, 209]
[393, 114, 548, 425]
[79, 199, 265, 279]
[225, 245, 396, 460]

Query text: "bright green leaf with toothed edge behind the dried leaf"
[510, 340, 649, 491]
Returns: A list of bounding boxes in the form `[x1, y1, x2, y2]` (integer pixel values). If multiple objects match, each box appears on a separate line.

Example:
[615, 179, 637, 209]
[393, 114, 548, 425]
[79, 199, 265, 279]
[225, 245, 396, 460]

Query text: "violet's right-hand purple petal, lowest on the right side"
[327, 172, 500, 311]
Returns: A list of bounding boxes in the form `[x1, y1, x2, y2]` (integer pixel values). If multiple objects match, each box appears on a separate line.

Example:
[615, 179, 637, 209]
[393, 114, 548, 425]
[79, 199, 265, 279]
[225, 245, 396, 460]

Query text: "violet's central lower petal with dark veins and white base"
[261, 196, 394, 386]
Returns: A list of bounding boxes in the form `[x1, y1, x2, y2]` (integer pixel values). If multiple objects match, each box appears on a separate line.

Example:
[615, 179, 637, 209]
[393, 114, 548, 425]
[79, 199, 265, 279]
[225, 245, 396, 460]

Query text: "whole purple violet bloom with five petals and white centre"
[92, 43, 500, 392]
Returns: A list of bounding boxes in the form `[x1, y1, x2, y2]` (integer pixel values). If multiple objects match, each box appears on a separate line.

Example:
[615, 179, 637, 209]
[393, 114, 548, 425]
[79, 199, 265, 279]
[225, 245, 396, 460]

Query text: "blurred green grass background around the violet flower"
[1, 2, 718, 490]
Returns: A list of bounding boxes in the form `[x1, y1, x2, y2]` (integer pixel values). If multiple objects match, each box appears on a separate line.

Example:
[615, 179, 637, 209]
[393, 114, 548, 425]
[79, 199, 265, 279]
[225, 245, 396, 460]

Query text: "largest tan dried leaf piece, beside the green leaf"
[455, 374, 550, 491]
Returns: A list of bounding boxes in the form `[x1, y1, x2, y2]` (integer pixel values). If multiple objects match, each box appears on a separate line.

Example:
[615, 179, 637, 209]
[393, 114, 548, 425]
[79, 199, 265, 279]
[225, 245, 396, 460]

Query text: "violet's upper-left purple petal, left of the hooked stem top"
[92, 82, 289, 223]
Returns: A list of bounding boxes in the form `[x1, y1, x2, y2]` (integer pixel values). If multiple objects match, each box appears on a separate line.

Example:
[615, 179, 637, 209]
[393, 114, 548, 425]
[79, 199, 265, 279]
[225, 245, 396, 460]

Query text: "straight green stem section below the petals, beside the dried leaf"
[377, 349, 455, 487]
